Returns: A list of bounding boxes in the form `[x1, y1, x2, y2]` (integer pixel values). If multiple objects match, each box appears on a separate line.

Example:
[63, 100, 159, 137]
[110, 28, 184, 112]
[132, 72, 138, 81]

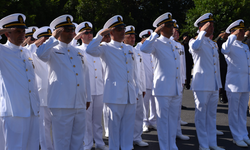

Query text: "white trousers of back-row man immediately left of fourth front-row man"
[143, 89, 157, 126]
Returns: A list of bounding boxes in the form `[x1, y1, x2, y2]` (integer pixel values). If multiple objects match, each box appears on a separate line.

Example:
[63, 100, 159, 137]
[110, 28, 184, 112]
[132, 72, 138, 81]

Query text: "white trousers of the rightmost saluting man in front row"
[227, 91, 249, 141]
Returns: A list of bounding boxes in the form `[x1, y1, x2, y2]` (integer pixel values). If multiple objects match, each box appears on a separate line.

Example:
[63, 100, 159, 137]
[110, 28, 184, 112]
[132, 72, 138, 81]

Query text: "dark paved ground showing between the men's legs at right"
[96, 90, 250, 150]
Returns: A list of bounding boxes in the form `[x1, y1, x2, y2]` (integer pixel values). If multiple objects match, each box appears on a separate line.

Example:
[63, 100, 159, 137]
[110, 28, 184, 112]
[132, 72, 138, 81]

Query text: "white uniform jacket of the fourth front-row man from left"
[141, 32, 182, 96]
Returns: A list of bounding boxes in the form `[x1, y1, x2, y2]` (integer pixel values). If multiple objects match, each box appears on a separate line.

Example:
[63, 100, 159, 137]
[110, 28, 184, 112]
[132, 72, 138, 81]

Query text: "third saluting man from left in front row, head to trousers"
[86, 15, 138, 150]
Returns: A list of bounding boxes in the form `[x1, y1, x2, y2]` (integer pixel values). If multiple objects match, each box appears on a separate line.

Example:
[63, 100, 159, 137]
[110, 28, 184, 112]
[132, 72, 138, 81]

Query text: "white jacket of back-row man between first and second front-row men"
[27, 44, 49, 106]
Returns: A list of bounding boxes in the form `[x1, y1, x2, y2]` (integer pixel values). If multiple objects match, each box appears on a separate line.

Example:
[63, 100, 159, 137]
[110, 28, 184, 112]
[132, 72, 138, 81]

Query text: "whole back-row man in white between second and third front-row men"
[73, 21, 108, 150]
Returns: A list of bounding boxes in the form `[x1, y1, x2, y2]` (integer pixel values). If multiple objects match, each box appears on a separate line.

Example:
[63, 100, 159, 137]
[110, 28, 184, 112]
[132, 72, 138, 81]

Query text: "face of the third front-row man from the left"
[110, 26, 125, 42]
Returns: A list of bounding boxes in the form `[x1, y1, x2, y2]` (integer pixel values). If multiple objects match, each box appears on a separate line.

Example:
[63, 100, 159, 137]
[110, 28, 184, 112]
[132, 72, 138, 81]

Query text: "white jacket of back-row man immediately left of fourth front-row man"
[135, 42, 154, 90]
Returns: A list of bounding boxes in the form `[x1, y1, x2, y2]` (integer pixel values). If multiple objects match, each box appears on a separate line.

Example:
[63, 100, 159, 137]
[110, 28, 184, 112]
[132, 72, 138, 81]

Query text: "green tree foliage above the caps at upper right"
[184, 0, 250, 36]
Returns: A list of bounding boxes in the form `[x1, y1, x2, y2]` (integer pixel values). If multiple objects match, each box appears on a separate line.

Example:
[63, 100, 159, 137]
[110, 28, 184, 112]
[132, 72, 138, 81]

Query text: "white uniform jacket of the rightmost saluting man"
[221, 35, 250, 92]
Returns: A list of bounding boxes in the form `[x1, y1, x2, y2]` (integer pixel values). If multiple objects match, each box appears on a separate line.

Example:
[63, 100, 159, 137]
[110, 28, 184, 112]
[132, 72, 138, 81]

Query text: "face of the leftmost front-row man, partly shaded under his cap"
[5, 28, 25, 46]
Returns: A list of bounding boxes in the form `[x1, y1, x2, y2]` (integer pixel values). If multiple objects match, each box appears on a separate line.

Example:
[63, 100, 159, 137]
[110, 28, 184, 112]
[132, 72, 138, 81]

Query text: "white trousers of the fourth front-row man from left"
[155, 96, 181, 150]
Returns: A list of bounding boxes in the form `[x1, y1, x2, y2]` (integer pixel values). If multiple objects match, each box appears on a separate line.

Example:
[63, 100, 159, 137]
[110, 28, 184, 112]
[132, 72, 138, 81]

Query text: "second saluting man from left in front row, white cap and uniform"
[37, 15, 91, 150]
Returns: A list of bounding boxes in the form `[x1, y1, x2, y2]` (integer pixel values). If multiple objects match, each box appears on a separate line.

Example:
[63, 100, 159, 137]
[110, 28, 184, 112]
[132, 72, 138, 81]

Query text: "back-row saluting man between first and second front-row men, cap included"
[28, 26, 54, 150]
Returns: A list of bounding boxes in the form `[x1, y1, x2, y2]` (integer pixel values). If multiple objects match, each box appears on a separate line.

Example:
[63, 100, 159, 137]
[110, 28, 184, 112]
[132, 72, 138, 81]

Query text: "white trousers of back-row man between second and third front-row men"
[84, 95, 105, 149]
